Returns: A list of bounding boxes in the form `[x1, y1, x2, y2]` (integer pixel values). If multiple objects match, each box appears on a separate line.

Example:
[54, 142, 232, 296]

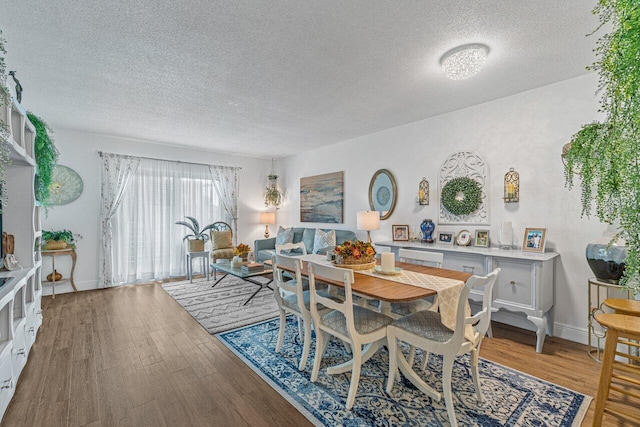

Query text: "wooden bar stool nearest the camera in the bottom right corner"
[592, 313, 640, 426]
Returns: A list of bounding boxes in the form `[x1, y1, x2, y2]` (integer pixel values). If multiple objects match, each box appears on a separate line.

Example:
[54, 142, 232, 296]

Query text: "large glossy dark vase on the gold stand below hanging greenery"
[586, 232, 629, 284]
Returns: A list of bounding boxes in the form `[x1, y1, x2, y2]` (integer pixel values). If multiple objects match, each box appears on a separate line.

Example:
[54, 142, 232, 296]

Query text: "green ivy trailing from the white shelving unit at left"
[27, 112, 58, 207]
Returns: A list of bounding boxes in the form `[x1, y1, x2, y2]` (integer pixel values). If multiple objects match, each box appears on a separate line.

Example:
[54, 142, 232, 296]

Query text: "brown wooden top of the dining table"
[267, 261, 471, 302]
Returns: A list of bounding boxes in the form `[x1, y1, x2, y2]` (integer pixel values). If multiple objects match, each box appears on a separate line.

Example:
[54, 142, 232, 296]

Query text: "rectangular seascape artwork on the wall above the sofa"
[300, 172, 344, 224]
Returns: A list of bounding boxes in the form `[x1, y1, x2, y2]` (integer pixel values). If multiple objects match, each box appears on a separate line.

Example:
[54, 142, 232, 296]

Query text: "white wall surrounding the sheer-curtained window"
[42, 129, 271, 295]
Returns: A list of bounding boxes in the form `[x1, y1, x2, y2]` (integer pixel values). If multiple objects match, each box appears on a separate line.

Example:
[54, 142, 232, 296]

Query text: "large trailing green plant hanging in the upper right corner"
[563, 0, 640, 293]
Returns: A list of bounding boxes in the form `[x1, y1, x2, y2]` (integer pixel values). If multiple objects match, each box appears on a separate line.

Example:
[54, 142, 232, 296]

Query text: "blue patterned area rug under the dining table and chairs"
[216, 317, 591, 427]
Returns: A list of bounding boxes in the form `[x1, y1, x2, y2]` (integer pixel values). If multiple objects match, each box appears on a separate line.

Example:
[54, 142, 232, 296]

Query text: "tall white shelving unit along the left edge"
[0, 96, 42, 416]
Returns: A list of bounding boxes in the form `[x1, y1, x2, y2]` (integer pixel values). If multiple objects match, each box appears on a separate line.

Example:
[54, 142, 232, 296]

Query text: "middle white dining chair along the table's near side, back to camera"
[308, 262, 393, 410]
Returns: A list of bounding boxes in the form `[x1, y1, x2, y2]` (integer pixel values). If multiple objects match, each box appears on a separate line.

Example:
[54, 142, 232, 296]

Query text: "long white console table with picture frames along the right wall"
[375, 242, 558, 353]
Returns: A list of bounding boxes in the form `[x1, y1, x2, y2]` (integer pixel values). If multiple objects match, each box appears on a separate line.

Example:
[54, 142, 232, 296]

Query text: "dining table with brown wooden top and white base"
[267, 254, 472, 375]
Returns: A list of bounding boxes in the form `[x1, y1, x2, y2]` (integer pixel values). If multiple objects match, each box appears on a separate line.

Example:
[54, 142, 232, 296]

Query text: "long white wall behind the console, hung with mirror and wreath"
[278, 74, 606, 342]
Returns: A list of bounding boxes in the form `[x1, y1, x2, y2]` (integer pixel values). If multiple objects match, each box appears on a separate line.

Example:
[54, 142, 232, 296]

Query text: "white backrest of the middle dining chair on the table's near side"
[307, 262, 355, 333]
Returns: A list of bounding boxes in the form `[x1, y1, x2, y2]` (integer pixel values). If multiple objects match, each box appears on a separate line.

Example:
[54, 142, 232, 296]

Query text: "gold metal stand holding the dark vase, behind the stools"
[587, 277, 632, 362]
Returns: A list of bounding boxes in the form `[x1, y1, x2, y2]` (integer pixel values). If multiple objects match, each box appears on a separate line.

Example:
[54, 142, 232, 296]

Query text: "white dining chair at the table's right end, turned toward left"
[387, 268, 500, 427]
